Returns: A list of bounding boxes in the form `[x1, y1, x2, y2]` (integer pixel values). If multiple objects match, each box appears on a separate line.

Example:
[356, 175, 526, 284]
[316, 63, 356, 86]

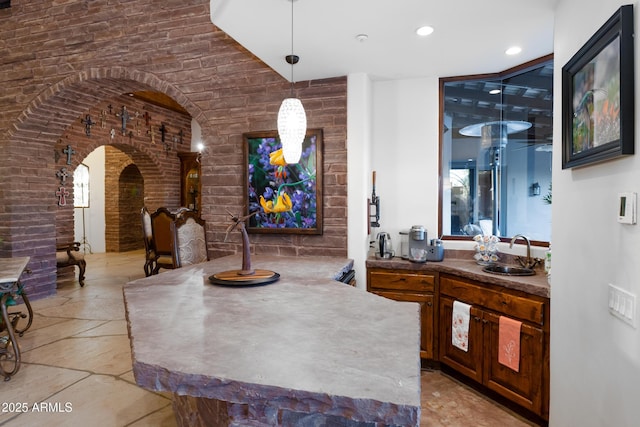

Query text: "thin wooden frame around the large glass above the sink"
[438, 53, 555, 247]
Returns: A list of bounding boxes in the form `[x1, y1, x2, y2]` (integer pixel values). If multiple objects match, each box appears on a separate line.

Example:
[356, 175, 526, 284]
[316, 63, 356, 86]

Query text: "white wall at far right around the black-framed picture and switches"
[550, 0, 640, 427]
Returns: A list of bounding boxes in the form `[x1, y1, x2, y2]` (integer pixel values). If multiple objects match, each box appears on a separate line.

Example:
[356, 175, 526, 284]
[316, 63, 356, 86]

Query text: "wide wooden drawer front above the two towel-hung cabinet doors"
[440, 276, 544, 325]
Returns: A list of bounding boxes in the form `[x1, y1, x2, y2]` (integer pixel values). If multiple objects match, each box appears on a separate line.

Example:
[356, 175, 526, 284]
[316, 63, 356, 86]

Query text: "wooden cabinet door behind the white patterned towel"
[438, 295, 483, 382]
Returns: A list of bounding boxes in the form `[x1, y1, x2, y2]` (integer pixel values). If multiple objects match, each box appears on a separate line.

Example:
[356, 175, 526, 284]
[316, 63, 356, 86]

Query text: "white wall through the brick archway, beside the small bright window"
[74, 146, 106, 253]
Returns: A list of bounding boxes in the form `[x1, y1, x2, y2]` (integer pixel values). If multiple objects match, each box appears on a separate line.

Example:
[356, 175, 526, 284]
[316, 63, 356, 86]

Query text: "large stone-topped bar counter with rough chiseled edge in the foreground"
[123, 255, 420, 426]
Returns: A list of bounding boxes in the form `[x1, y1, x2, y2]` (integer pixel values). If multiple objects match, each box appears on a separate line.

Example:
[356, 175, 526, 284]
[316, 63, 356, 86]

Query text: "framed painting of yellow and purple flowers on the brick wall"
[243, 129, 323, 234]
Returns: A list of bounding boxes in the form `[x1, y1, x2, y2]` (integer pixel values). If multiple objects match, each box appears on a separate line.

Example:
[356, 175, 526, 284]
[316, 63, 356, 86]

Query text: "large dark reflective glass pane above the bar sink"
[439, 55, 553, 242]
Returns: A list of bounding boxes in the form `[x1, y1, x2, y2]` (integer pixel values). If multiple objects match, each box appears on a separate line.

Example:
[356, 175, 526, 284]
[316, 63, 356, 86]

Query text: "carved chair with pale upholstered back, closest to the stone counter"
[171, 211, 209, 267]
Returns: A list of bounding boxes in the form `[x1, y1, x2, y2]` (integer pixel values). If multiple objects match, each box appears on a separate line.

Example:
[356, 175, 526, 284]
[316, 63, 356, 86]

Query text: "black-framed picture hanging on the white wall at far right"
[562, 5, 635, 169]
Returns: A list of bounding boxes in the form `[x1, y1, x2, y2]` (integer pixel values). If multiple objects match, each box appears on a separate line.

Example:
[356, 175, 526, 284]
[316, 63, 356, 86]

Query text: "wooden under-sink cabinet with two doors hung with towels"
[439, 274, 549, 419]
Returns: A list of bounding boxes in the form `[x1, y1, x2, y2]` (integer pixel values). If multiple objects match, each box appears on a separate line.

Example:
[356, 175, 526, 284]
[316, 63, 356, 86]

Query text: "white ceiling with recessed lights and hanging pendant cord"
[211, 0, 559, 81]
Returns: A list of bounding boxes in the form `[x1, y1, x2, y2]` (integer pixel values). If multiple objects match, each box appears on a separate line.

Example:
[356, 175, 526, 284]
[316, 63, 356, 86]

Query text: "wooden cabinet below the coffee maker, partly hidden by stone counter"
[367, 269, 437, 359]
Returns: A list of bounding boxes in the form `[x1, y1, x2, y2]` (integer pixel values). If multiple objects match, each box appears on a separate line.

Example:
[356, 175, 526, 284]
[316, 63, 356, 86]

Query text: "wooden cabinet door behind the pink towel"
[483, 312, 545, 414]
